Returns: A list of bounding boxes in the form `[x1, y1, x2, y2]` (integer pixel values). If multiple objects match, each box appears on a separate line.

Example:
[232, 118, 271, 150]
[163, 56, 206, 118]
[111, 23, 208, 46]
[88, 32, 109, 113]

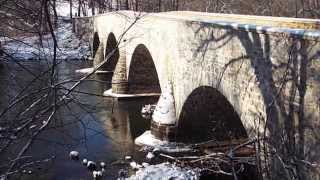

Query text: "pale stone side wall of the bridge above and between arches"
[73, 11, 320, 179]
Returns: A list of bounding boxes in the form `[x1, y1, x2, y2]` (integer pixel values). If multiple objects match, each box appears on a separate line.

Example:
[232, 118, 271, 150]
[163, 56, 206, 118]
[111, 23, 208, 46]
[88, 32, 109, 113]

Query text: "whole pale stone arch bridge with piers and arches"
[73, 11, 320, 179]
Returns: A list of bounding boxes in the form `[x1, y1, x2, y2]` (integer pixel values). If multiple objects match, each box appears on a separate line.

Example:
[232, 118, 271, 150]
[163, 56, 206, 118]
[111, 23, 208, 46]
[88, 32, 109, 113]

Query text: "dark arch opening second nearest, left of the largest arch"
[128, 44, 161, 93]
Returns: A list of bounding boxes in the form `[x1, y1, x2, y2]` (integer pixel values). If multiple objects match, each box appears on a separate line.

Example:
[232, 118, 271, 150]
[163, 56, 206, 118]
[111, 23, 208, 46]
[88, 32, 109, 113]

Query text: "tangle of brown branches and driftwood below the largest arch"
[159, 139, 256, 179]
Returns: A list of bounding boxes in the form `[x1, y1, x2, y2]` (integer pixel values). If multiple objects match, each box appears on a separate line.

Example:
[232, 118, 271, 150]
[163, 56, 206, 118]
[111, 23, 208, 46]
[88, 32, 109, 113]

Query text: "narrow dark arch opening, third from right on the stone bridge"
[101, 32, 119, 71]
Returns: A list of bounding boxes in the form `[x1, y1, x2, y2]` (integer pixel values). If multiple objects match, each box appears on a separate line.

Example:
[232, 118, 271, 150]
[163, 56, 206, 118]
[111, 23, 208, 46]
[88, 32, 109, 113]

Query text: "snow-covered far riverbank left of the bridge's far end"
[0, 20, 90, 60]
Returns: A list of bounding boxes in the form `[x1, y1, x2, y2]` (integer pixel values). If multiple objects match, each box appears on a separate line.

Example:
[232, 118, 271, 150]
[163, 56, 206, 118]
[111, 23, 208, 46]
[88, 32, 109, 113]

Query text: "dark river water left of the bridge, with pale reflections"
[0, 61, 157, 180]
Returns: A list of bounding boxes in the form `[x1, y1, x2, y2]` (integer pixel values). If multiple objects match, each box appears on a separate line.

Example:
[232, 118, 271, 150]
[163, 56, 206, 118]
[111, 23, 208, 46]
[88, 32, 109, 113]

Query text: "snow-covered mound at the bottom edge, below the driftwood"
[127, 163, 200, 180]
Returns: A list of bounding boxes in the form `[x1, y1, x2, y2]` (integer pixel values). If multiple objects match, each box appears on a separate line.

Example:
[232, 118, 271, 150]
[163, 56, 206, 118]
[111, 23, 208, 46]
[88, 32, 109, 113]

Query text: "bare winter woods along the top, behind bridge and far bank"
[0, 0, 320, 52]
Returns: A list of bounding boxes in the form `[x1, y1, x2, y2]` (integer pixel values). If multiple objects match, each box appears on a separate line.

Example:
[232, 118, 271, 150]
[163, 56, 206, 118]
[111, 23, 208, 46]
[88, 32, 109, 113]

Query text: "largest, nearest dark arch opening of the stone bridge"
[177, 86, 248, 142]
